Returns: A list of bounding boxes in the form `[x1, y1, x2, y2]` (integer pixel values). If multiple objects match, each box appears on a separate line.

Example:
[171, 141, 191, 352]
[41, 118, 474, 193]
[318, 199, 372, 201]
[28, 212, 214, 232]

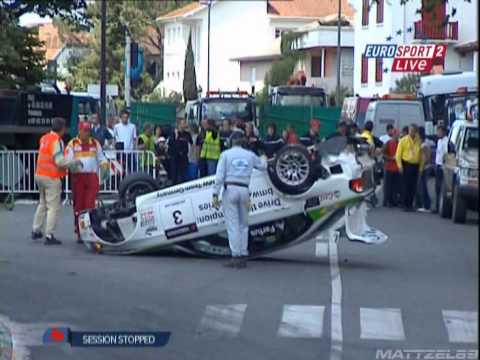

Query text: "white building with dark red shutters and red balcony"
[349, 0, 478, 96]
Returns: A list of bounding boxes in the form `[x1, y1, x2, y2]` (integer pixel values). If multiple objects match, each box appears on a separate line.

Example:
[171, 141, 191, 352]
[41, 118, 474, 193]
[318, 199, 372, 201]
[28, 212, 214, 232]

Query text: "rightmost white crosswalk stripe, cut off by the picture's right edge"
[442, 310, 478, 343]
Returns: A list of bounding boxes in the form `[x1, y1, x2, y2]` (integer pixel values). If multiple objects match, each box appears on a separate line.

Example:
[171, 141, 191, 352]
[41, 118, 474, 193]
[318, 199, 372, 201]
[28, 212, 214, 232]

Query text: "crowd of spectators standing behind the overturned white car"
[84, 107, 447, 211]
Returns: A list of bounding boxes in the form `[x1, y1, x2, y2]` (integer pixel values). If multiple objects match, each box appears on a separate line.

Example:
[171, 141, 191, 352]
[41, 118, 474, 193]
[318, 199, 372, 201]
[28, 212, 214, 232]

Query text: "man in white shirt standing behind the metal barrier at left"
[113, 110, 137, 172]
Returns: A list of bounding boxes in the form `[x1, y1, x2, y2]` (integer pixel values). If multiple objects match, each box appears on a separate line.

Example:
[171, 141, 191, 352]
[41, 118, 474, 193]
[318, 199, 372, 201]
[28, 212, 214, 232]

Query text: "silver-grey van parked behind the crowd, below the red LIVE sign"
[365, 100, 427, 137]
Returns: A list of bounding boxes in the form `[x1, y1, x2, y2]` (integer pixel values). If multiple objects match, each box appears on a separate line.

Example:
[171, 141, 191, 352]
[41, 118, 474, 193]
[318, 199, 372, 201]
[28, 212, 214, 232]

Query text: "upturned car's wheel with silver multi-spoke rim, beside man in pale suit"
[268, 145, 315, 195]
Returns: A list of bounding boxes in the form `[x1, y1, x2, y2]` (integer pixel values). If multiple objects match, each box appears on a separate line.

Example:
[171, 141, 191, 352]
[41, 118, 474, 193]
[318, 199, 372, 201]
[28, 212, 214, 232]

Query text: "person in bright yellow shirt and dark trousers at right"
[395, 124, 424, 211]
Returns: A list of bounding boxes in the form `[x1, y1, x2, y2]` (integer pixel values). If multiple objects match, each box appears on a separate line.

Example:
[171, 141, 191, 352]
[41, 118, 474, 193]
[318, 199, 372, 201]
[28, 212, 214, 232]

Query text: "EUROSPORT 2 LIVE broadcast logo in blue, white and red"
[363, 44, 447, 73]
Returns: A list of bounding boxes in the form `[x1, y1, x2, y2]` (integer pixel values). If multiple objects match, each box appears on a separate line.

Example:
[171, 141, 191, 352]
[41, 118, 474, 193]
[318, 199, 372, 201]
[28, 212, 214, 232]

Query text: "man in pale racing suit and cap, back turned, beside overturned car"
[213, 132, 267, 268]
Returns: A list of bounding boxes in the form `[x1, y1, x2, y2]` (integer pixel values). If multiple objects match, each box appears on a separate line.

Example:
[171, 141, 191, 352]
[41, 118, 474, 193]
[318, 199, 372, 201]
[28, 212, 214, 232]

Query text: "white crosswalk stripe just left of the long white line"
[278, 305, 325, 338]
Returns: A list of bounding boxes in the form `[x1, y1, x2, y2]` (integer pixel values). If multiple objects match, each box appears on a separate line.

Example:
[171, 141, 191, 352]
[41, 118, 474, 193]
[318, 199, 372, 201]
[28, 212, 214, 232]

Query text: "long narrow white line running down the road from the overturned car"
[328, 227, 343, 360]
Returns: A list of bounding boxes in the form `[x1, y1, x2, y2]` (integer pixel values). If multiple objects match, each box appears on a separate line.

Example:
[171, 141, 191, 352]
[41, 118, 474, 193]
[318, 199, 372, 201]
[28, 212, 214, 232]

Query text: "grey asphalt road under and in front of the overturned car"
[0, 205, 478, 360]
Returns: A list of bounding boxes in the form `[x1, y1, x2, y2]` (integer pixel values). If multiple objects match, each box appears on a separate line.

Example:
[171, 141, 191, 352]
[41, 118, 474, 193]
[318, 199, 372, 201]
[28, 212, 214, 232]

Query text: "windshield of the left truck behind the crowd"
[202, 101, 253, 121]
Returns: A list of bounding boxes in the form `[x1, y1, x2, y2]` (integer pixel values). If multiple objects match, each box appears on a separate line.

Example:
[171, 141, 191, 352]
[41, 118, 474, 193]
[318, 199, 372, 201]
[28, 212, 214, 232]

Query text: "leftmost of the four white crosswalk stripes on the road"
[196, 304, 247, 338]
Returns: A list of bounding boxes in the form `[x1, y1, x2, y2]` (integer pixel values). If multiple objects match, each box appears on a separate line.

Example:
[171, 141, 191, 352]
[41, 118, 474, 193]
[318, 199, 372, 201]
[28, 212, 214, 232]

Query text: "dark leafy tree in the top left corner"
[0, 0, 88, 89]
